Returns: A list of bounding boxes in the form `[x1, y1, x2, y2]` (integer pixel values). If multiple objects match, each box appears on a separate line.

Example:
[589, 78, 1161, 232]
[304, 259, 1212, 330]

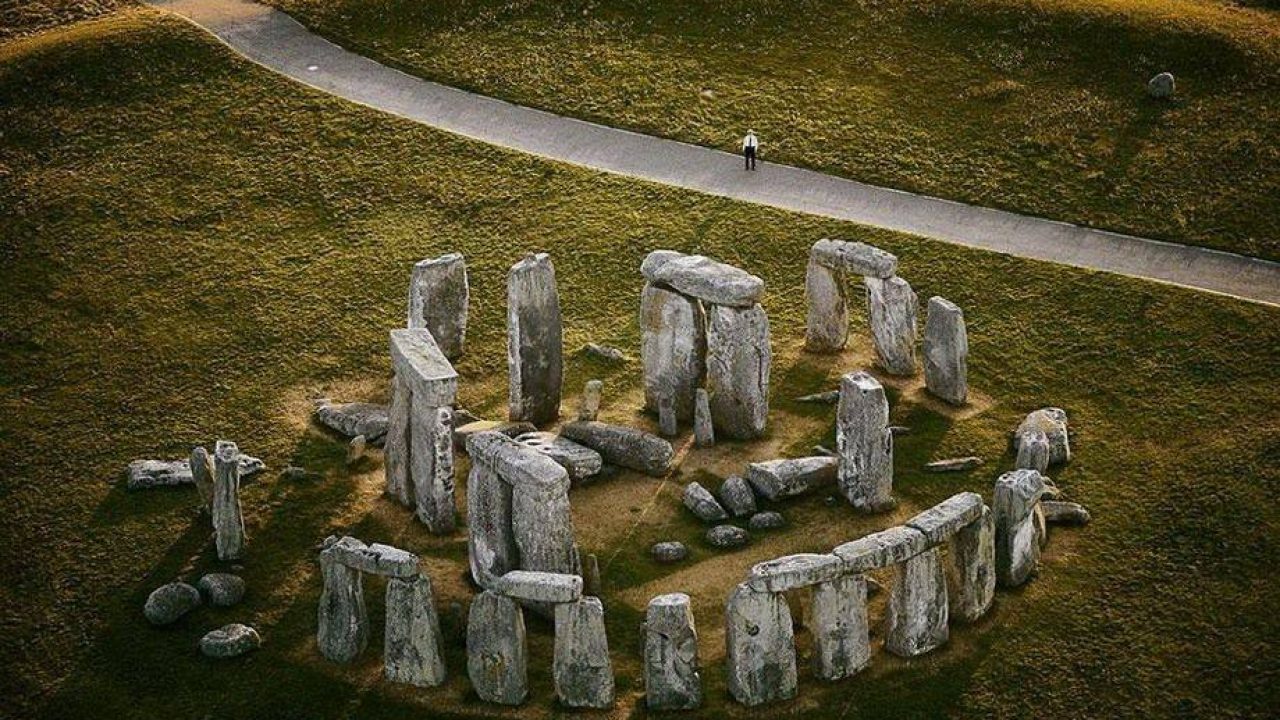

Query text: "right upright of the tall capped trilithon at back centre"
[707, 304, 773, 439]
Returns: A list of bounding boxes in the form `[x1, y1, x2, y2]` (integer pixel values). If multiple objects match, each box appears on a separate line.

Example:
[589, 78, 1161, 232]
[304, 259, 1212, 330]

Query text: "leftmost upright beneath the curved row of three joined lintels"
[724, 583, 796, 707]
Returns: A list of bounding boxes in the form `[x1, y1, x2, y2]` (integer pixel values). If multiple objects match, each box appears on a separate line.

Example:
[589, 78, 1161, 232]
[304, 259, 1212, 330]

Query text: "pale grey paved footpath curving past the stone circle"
[152, 0, 1280, 305]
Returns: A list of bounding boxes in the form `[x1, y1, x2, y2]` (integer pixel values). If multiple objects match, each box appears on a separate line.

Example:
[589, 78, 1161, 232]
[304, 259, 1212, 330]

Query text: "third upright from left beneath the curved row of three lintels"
[884, 547, 950, 657]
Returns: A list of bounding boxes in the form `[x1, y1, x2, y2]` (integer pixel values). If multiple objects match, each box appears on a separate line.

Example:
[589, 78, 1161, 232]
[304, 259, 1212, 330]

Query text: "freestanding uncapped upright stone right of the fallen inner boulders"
[836, 372, 893, 512]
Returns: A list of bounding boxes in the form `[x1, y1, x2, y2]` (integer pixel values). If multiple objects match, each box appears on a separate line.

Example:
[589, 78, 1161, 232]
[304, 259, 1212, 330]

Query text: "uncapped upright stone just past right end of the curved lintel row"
[991, 470, 1044, 587]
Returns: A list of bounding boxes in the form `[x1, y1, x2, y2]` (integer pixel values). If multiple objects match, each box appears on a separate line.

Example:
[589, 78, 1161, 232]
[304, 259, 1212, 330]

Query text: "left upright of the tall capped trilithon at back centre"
[640, 278, 707, 420]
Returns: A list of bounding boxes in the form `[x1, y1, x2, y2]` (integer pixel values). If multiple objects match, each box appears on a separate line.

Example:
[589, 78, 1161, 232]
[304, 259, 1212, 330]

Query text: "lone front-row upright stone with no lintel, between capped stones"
[644, 593, 703, 710]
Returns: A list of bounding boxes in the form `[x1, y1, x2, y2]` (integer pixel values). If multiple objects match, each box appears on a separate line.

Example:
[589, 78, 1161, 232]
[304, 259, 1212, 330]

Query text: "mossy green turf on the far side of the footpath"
[269, 0, 1280, 259]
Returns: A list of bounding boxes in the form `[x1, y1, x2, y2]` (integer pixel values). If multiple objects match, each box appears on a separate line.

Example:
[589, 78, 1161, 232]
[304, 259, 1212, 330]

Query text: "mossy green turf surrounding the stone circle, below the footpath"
[0, 10, 1280, 719]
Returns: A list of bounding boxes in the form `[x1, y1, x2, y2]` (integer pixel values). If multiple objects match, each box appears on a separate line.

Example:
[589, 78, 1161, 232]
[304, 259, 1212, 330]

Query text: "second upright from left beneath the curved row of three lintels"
[809, 575, 872, 680]
